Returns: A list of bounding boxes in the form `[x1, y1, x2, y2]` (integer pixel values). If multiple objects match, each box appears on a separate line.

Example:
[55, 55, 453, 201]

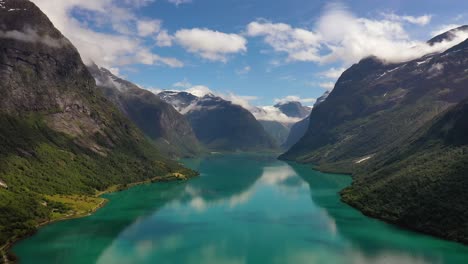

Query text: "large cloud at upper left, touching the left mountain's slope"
[32, 0, 183, 68]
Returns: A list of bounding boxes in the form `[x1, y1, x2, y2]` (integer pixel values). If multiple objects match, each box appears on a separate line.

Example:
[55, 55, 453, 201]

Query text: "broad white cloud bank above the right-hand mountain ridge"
[246, 4, 468, 66]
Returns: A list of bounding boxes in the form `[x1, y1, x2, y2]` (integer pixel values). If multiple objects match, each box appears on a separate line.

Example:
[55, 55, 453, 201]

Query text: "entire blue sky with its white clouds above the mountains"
[33, 0, 468, 105]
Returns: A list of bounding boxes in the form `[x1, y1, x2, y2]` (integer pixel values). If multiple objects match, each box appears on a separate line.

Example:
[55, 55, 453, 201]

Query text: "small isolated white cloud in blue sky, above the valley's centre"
[174, 28, 247, 62]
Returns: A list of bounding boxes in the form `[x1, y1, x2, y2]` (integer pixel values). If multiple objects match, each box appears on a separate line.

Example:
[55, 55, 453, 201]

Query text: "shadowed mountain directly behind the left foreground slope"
[88, 65, 202, 157]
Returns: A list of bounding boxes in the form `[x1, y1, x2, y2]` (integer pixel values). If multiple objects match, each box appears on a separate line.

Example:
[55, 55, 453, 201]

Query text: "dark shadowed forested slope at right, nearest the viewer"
[342, 100, 468, 244]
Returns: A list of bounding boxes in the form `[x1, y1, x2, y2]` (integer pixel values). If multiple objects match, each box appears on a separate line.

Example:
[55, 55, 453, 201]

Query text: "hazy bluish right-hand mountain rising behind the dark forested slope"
[282, 30, 468, 172]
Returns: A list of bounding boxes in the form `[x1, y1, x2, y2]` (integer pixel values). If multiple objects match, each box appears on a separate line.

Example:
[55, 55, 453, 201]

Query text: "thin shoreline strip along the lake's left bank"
[0, 173, 199, 264]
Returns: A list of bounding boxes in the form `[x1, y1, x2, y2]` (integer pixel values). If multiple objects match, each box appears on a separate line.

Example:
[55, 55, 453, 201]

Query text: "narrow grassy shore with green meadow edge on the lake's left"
[0, 172, 198, 263]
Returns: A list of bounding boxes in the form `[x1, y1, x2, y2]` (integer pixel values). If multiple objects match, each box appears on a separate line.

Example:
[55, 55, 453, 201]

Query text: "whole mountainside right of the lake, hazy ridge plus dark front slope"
[281, 26, 468, 243]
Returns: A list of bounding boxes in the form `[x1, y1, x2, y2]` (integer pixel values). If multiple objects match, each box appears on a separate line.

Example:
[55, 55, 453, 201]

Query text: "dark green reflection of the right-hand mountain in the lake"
[291, 164, 467, 264]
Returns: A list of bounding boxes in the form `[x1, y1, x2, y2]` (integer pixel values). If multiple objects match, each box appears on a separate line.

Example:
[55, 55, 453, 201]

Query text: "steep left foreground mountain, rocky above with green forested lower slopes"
[0, 0, 194, 245]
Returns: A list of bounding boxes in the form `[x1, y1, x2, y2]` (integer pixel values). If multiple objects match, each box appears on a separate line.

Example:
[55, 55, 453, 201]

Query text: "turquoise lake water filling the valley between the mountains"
[13, 154, 468, 264]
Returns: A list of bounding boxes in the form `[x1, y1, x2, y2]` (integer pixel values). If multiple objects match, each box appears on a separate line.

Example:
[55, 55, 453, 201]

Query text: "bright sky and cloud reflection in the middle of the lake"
[93, 160, 437, 264]
